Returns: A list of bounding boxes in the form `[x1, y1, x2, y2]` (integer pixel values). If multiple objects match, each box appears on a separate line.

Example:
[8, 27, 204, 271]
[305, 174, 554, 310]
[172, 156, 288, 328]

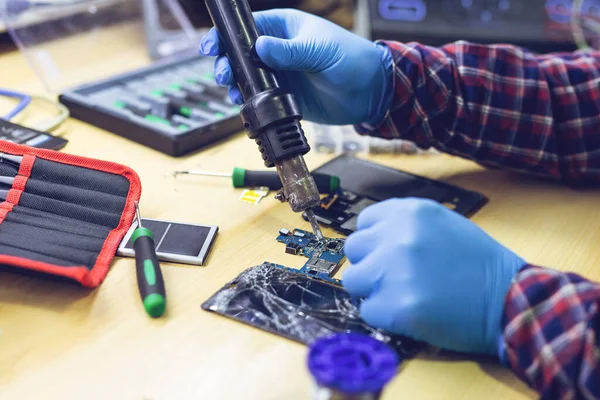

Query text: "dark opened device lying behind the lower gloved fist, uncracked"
[304, 156, 488, 235]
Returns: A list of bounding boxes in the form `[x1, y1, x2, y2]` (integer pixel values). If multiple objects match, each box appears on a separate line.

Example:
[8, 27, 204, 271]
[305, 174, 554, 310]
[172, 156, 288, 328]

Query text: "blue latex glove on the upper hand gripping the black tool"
[200, 10, 393, 125]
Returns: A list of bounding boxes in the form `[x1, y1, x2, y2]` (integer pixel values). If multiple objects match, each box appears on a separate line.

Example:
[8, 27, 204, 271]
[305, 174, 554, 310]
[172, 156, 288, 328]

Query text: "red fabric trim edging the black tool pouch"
[0, 141, 142, 287]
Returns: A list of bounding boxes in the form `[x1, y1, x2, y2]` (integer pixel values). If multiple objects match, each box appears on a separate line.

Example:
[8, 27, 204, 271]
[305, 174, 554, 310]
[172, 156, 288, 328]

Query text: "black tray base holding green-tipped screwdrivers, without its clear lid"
[59, 56, 242, 156]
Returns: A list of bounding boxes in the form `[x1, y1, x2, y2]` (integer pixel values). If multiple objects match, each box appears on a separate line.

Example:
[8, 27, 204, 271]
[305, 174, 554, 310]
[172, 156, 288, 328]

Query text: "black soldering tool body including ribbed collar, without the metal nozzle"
[206, 0, 310, 167]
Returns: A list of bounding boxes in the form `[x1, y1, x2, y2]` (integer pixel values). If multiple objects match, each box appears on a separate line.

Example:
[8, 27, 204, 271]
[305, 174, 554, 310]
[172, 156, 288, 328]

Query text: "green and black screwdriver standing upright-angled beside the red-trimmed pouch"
[131, 201, 167, 318]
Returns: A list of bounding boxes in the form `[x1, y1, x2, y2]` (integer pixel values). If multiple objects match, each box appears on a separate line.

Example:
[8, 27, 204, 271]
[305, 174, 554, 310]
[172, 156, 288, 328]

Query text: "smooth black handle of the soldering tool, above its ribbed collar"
[206, 0, 278, 100]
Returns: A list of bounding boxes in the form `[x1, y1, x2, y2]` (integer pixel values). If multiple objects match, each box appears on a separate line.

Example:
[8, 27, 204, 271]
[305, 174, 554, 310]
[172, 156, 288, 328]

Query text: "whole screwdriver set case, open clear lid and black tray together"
[0, 0, 243, 156]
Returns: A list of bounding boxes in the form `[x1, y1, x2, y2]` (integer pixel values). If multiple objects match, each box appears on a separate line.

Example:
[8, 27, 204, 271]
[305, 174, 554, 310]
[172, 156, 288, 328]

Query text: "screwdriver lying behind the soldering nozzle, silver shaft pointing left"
[174, 168, 340, 193]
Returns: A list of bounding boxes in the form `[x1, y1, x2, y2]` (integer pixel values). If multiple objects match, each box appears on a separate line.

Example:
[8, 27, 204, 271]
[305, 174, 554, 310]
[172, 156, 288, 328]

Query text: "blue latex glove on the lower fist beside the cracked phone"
[343, 199, 525, 358]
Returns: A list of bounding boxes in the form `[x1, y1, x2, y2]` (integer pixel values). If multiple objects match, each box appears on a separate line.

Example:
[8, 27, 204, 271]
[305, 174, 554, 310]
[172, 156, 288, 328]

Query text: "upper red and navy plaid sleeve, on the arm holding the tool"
[356, 42, 600, 185]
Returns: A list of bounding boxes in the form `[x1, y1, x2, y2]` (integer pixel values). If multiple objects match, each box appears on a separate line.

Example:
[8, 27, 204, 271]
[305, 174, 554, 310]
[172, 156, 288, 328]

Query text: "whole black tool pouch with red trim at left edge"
[0, 141, 141, 287]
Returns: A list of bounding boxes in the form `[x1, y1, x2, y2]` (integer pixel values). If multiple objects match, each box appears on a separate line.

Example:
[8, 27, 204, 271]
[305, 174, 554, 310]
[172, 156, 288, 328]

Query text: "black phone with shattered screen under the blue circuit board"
[202, 263, 424, 358]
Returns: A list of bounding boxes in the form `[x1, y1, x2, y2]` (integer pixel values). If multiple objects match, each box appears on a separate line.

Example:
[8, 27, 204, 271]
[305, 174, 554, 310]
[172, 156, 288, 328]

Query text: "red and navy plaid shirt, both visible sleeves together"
[356, 42, 600, 399]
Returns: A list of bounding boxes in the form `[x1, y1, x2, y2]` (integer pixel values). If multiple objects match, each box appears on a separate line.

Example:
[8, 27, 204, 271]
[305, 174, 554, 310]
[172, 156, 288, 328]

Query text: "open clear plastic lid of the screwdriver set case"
[0, 0, 198, 93]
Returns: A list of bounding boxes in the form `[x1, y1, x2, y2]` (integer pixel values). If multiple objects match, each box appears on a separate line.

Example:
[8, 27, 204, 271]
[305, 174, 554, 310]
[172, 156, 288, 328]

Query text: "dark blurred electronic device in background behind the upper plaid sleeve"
[369, 0, 600, 52]
